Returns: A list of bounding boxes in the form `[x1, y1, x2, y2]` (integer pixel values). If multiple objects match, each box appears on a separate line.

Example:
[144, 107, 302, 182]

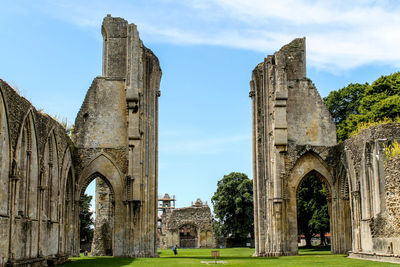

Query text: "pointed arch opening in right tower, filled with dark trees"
[297, 171, 331, 248]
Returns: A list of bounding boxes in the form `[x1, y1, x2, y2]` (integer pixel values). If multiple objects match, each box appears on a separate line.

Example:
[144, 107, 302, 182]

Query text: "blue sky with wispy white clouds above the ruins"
[0, 0, 400, 210]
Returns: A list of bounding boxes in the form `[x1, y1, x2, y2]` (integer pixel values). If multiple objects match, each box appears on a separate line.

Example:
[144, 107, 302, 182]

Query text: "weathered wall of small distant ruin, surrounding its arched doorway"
[160, 205, 216, 249]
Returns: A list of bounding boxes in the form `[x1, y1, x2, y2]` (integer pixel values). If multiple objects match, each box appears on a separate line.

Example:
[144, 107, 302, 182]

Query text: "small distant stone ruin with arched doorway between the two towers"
[160, 199, 216, 248]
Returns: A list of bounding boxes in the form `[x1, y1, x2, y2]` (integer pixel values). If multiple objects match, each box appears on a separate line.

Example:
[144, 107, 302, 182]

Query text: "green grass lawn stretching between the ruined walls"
[67, 248, 399, 267]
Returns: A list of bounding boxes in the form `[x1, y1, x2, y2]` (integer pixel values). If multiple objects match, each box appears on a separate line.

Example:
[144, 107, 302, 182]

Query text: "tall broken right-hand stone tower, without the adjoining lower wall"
[250, 38, 336, 256]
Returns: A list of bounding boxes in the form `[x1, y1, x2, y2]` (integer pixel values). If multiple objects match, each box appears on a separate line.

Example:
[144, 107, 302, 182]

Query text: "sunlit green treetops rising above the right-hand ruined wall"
[324, 72, 400, 142]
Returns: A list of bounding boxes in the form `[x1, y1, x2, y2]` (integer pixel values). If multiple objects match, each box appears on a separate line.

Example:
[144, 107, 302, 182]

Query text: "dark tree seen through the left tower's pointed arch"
[79, 194, 94, 243]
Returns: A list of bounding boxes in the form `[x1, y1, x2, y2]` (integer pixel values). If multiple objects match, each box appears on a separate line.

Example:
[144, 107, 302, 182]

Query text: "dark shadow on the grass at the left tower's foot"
[65, 257, 135, 267]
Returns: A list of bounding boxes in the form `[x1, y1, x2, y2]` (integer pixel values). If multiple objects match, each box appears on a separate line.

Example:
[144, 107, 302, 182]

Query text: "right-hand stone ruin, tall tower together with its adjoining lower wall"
[250, 38, 400, 262]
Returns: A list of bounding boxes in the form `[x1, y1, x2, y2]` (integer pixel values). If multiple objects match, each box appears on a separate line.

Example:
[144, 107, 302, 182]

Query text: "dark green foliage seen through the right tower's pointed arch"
[297, 174, 329, 247]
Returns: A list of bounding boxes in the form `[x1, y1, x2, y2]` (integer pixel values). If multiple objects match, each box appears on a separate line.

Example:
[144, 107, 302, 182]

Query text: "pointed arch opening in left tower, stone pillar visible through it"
[80, 172, 114, 256]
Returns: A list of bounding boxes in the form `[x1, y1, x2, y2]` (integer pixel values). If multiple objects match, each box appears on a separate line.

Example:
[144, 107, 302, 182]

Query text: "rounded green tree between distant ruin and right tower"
[211, 172, 254, 243]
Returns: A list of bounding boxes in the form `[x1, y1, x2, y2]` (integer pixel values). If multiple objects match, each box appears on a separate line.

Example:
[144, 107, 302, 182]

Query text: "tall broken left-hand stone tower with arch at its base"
[75, 15, 161, 257]
